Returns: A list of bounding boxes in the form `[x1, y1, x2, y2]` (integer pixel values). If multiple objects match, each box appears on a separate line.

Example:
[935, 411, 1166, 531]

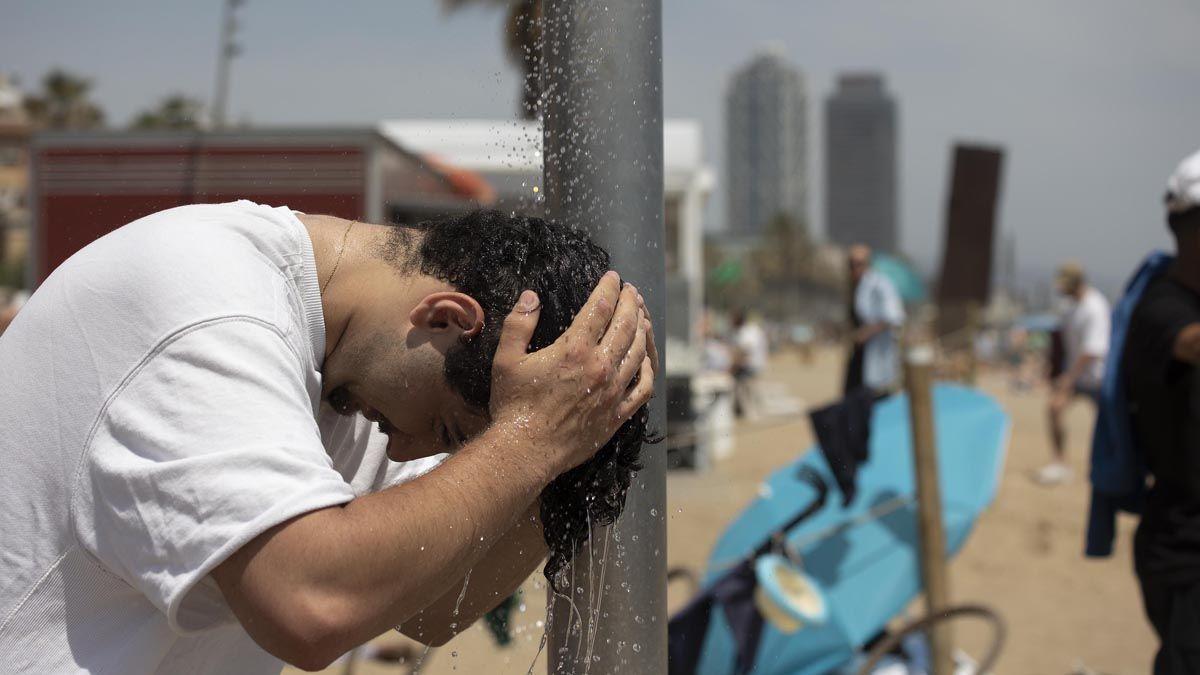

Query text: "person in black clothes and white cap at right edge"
[1122, 153, 1200, 675]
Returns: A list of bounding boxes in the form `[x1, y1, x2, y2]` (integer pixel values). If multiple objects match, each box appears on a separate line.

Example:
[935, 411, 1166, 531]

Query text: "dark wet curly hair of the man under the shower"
[384, 210, 658, 591]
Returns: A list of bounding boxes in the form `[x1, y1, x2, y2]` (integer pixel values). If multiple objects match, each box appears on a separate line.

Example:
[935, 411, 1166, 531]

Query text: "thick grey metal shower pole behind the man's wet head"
[541, 0, 667, 675]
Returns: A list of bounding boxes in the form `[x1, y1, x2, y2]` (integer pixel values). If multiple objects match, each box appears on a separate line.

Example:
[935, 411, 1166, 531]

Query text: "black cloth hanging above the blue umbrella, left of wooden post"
[809, 389, 876, 506]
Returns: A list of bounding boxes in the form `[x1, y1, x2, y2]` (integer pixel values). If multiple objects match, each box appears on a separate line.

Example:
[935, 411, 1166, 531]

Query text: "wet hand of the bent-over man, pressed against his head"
[491, 271, 658, 476]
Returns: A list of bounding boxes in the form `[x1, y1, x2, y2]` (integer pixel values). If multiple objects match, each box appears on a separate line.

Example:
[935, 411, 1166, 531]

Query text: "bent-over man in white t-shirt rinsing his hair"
[0, 201, 658, 675]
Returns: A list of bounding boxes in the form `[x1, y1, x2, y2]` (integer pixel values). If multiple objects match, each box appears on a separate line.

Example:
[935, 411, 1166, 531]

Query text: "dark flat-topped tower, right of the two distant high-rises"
[826, 73, 899, 252]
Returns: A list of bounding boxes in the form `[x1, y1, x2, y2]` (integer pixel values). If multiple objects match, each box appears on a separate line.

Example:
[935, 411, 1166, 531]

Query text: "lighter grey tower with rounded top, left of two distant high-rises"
[725, 47, 808, 235]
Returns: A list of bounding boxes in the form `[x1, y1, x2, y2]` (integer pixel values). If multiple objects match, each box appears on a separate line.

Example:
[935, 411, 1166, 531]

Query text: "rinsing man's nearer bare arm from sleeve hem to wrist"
[217, 420, 553, 662]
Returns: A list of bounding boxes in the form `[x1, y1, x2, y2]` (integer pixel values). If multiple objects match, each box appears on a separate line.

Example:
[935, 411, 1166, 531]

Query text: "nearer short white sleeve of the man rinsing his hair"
[72, 319, 354, 633]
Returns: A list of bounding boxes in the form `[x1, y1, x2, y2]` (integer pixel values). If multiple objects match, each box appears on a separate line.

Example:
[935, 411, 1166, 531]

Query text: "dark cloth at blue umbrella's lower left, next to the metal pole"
[667, 560, 763, 675]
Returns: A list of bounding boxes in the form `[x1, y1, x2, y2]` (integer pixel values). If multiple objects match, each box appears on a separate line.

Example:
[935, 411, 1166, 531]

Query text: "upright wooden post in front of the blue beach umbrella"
[905, 345, 954, 675]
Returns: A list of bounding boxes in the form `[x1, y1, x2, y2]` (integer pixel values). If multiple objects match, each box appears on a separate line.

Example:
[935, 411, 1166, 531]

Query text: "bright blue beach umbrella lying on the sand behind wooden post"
[697, 384, 1009, 675]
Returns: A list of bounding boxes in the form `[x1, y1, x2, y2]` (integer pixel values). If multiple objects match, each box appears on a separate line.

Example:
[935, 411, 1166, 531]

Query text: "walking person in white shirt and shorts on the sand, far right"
[1033, 258, 1112, 485]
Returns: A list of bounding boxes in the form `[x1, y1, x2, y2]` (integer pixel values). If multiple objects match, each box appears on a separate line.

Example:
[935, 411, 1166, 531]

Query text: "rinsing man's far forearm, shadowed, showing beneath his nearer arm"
[400, 501, 547, 645]
